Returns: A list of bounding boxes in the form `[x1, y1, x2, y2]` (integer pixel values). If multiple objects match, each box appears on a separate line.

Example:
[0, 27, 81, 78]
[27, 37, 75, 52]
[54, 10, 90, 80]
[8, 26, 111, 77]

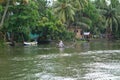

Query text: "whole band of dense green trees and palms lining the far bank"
[0, 0, 120, 42]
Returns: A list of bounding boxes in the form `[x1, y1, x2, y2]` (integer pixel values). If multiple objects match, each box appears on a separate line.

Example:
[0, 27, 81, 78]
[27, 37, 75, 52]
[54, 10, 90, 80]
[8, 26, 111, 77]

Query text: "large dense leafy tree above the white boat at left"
[3, 0, 39, 41]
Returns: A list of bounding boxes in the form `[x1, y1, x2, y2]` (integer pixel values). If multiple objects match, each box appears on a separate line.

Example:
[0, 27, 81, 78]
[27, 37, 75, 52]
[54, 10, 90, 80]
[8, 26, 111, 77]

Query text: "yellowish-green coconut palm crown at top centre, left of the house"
[53, 0, 76, 26]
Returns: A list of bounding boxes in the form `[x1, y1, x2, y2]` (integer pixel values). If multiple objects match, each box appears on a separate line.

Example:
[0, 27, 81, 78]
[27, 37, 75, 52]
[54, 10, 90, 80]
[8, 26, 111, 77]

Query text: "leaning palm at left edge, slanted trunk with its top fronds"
[0, 0, 28, 43]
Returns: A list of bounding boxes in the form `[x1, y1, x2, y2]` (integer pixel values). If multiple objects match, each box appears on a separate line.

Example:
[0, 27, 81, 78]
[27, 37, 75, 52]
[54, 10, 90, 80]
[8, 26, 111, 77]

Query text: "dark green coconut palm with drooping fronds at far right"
[104, 0, 120, 38]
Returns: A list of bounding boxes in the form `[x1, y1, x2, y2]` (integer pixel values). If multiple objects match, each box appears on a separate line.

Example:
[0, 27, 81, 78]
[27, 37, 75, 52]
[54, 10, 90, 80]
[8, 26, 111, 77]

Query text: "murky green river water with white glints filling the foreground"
[0, 41, 120, 80]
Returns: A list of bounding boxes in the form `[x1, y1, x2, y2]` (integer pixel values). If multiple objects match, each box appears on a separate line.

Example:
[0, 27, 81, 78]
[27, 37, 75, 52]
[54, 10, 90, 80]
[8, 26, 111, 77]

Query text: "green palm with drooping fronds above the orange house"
[74, 0, 95, 30]
